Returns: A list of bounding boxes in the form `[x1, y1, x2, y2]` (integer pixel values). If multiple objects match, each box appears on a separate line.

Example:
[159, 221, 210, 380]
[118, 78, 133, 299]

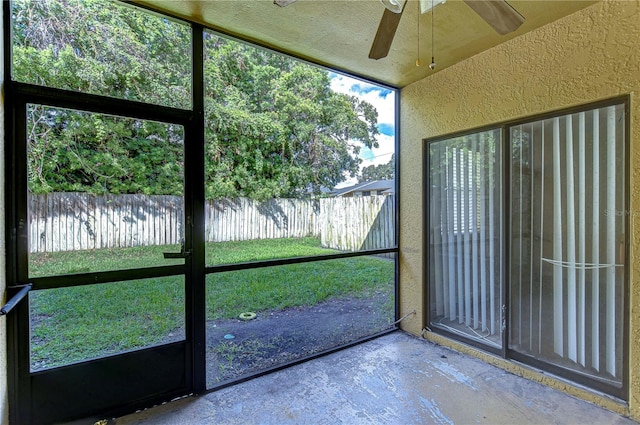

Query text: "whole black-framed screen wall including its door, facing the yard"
[3, 0, 399, 424]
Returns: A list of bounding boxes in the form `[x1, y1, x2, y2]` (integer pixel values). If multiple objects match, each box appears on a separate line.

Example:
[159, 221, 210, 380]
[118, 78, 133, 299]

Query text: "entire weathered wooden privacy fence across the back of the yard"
[28, 193, 395, 252]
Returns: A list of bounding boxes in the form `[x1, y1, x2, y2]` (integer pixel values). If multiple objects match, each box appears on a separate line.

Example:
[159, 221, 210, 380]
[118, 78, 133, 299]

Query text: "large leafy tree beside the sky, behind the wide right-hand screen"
[205, 36, 378, 199]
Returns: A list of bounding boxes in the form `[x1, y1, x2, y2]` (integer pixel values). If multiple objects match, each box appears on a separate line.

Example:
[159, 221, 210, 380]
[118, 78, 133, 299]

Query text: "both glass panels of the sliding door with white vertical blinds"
[428, 102, 629, 393]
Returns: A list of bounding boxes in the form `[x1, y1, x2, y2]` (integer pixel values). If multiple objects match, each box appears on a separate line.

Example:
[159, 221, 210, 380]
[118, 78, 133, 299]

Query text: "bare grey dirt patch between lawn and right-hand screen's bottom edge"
[207, 292, 393, 387]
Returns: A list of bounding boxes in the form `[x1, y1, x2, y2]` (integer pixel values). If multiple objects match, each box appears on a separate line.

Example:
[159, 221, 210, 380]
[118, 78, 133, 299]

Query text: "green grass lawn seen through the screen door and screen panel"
[30, 238, 394, 369]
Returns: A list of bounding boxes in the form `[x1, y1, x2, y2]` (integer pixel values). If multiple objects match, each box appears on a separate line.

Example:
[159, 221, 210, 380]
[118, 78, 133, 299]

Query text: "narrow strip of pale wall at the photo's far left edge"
[0, 1, 9, 424]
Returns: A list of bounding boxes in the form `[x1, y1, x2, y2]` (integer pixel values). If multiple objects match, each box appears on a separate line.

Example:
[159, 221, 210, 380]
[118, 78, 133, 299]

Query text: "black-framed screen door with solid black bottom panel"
[16, 102, 193, 423]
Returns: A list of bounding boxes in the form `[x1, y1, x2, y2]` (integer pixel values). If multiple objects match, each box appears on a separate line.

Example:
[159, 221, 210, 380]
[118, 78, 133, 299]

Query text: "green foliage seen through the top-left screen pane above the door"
[12, 0, 191, 108]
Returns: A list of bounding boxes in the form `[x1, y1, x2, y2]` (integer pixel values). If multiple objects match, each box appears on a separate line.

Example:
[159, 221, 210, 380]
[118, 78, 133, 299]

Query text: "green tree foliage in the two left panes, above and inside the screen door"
[12, 0, 191, 194]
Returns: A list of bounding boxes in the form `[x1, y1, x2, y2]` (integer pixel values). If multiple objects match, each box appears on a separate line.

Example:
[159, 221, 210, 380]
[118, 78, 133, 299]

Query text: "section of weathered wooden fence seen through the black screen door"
[28, 193, 184, 252]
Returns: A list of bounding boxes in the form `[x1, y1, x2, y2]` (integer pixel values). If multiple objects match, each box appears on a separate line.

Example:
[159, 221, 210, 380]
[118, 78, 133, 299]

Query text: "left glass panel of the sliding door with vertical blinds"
[428, 130, 503, 348]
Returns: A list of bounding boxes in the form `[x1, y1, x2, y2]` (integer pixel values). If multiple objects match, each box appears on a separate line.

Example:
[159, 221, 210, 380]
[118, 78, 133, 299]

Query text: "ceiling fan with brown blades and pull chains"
[273, 0, 524, 59]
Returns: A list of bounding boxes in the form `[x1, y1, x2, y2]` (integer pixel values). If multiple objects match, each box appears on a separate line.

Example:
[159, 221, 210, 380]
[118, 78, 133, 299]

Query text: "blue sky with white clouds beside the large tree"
[329, 72, 395, 186]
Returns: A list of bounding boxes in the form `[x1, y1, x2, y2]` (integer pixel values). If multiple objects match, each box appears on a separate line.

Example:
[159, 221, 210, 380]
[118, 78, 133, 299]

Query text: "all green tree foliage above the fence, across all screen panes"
[12, 0, 378, 200]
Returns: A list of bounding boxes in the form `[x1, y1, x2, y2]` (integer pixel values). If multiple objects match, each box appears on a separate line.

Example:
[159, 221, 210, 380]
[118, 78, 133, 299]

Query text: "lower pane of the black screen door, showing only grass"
[29, 276, 185, 372]
